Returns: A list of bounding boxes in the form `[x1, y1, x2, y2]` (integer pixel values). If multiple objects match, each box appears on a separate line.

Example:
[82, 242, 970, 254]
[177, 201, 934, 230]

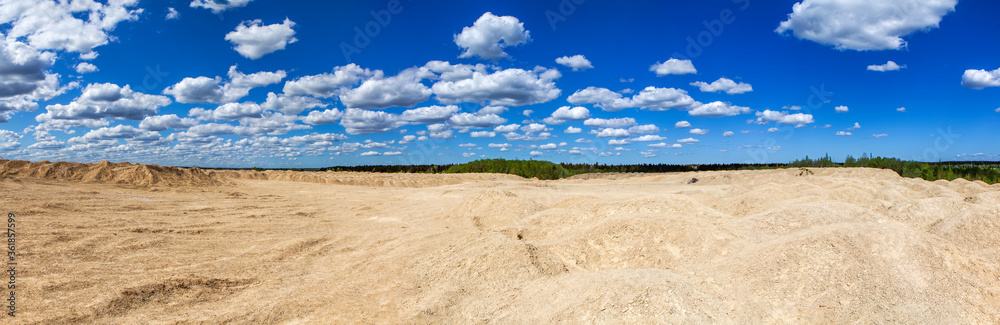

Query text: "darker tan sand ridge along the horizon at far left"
[0, 160, 225, 186]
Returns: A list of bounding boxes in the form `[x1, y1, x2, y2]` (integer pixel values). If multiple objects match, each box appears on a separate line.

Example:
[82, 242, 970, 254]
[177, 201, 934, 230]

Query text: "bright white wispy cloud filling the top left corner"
[0, 0, 143, 53]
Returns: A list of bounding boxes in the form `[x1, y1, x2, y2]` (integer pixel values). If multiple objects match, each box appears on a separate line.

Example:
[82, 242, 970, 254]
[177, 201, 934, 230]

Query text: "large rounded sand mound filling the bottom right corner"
[725, 223, 1000, 324]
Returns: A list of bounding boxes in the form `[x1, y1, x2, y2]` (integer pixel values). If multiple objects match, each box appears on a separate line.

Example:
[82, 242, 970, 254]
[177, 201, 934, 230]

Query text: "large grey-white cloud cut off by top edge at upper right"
[775, 0, 958, 51]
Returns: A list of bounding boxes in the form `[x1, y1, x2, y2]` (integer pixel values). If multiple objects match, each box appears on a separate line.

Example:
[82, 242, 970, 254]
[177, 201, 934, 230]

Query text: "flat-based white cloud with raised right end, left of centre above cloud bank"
[163, 65, 286, 103]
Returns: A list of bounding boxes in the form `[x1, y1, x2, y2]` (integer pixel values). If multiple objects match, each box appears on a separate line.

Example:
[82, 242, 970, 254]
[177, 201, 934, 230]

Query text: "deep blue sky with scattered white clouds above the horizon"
[0, 0, 1000, 167]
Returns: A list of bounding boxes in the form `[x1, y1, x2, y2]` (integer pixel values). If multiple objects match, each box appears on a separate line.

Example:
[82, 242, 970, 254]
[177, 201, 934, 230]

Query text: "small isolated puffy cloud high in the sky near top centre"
[455, 12, 530, 60]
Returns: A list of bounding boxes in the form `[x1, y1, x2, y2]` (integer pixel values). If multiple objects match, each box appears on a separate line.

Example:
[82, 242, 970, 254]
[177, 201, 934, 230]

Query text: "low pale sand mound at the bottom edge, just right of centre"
[476, 269, 727, 324]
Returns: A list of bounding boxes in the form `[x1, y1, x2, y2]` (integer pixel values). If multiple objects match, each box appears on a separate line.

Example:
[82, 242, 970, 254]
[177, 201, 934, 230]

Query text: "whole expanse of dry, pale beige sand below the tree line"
[0, 161, 1000, 324]
